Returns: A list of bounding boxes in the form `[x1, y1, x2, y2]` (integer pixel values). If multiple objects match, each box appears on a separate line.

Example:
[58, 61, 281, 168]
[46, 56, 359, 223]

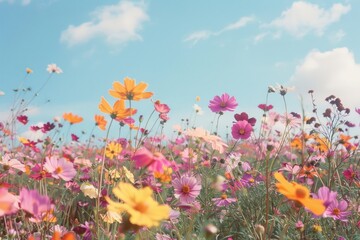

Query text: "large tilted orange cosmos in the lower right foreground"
[274, 172, 325, 215]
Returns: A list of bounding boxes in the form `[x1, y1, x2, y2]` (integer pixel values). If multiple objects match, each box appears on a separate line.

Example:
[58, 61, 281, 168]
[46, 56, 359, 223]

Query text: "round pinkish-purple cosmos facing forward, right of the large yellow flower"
[172, 176, 201, 203]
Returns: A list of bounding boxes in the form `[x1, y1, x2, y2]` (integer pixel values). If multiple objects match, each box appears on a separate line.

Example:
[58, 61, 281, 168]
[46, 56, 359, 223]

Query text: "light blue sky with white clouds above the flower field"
[0, 0, 360, 139]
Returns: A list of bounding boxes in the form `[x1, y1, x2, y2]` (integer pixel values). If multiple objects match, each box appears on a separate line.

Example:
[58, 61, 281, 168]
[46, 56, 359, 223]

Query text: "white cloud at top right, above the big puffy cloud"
[268, 1, 351, 38]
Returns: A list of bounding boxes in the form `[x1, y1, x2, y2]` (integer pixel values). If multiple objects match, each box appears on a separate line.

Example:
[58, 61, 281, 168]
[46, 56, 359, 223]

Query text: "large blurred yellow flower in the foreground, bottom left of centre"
[106, 182, 170, 228]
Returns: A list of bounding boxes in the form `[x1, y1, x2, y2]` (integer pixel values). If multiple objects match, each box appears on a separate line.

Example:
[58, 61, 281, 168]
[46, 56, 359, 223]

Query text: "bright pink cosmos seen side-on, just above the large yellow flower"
[132, 147, 171, 173]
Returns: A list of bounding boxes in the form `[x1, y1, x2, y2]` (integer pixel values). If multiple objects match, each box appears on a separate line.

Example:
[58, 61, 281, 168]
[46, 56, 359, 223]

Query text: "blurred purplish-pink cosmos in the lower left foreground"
[19, 188, 52, 221]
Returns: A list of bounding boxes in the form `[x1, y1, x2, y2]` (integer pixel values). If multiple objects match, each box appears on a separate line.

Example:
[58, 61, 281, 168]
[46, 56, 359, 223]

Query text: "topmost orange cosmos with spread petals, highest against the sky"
[109, 77, 153, 101]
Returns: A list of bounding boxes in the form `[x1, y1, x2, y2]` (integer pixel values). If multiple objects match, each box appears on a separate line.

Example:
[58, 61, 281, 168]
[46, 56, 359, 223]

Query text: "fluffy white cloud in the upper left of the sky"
[60, 1, 149, 46]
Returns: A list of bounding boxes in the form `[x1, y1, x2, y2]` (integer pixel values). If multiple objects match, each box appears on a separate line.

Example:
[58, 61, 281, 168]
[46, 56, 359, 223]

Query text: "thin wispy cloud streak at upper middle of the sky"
[184, 17, 254, 45]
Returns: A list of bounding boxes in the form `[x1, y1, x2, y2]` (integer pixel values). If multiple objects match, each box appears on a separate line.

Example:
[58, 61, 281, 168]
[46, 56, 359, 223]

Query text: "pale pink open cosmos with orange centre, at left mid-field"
[44, 156, 76, 181]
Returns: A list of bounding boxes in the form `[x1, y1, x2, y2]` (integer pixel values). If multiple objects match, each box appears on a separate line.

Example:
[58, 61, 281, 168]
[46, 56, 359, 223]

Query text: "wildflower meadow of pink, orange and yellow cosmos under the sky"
[0, 64, 360, 240]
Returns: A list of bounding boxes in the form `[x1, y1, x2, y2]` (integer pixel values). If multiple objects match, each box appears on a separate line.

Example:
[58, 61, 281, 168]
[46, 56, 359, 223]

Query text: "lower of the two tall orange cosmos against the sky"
[99, 97, 136, 119]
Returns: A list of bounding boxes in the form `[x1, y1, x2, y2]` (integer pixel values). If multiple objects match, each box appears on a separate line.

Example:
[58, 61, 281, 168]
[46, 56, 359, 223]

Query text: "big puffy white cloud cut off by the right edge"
[290, 47, 360, 109]
